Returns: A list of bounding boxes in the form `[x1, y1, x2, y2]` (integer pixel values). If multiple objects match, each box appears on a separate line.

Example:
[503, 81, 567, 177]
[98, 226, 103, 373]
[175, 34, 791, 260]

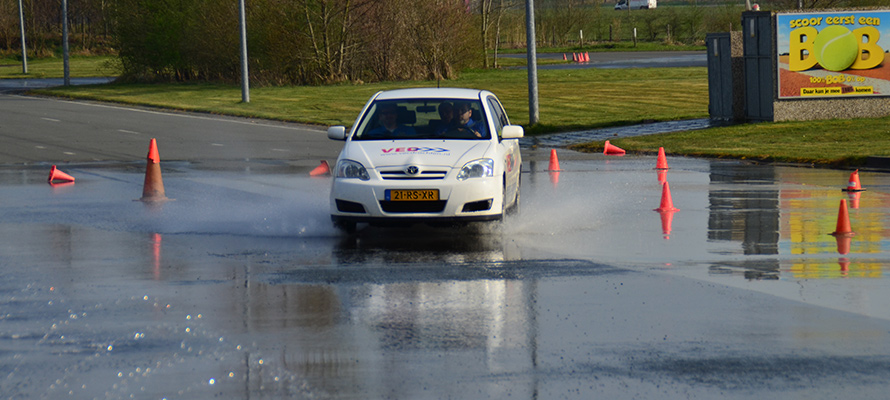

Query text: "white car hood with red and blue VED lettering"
[343, 140, 491, 168]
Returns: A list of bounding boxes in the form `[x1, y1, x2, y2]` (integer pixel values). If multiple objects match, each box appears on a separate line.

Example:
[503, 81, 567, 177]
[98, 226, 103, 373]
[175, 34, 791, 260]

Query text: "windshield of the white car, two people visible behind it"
[353, 99, 491, 140]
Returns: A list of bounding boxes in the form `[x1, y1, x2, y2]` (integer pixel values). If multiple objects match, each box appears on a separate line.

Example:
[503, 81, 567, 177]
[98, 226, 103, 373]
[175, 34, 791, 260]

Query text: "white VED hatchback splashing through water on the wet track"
[328, 88, 523, 232]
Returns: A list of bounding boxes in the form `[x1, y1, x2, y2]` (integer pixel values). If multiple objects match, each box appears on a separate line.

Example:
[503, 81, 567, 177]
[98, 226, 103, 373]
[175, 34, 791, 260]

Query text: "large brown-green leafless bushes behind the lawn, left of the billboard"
[114, 0, 474, 84]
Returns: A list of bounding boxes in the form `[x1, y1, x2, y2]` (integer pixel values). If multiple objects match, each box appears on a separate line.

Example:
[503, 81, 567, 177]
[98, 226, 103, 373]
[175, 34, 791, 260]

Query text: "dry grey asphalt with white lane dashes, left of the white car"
[0, 94, 343, 165]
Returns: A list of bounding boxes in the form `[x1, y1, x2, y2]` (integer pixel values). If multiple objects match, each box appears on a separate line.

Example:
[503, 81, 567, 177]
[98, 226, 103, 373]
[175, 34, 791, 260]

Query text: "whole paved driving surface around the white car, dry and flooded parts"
[0, 92, 890, 399]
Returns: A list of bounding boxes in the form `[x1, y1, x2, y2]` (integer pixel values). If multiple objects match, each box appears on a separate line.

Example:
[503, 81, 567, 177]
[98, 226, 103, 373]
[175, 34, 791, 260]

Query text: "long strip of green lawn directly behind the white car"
[38, 68, 708, 133]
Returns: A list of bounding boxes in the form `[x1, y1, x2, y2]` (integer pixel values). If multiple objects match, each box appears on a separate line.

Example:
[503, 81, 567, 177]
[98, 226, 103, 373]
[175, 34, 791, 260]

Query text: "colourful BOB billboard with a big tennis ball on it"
[776, 11, 890, 99]
